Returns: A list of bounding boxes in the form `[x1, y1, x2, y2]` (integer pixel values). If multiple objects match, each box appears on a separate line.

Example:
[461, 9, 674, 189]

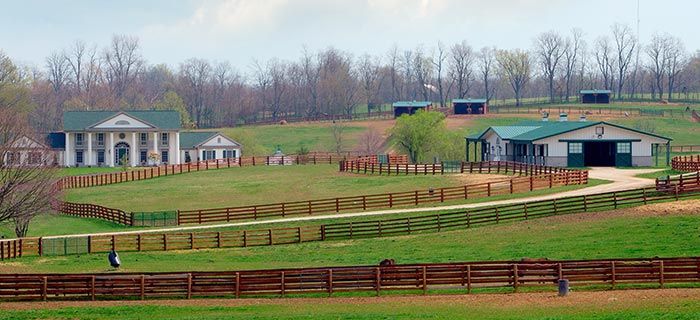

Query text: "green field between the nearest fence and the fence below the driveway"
[0, 200, 700, 272]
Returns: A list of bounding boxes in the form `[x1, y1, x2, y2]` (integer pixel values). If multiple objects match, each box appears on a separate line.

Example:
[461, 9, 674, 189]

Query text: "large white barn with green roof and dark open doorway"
[466, 114, 672, 167]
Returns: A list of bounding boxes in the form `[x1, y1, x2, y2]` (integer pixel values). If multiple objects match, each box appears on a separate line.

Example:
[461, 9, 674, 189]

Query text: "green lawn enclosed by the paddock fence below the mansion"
[66, 165, 504, 212]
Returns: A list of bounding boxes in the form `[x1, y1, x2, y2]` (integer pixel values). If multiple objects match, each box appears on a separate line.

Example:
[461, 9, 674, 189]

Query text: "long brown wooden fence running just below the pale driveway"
[6, 186, 700, 258]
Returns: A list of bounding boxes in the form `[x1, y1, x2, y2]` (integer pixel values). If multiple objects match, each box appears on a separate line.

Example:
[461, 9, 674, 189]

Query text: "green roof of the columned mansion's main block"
[63, 110, 181, 131]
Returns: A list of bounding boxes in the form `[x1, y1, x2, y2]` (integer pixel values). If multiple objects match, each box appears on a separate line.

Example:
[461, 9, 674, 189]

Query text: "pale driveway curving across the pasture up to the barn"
[38, 168, 658, 239]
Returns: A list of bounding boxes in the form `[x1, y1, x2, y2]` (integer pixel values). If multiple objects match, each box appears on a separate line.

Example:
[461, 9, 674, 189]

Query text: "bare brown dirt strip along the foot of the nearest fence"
[0, 289, 700, 310]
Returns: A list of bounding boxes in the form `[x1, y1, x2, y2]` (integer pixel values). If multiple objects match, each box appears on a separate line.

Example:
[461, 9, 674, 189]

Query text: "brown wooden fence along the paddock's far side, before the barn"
[339, 160, 588, 181]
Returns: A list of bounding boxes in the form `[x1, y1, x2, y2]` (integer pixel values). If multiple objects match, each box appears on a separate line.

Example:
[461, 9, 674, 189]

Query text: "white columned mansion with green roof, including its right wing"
[56, 110, 240, 167]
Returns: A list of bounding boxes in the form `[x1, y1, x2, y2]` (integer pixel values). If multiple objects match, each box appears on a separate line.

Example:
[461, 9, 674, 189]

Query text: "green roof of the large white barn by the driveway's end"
[468, 121, 673, 142]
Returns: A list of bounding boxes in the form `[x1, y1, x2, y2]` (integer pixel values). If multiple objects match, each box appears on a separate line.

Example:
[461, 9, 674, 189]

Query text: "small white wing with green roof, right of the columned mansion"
[180, 131, 241, 163]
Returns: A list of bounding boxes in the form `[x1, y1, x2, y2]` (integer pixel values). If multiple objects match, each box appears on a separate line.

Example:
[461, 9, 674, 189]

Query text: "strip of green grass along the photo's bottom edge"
[0, 298, 700, 320]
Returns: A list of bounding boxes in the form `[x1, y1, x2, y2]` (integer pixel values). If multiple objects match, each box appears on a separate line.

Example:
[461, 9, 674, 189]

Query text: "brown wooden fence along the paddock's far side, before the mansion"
[59, 154, 372, 189]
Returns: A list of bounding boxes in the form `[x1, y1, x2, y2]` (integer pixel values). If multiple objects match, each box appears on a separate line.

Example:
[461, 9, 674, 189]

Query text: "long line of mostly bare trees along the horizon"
[0, 24, 700, 130]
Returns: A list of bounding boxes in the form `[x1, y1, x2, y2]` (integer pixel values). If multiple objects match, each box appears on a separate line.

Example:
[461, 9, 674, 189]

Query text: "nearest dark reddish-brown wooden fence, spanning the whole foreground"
[0, 257, 700, 301]
